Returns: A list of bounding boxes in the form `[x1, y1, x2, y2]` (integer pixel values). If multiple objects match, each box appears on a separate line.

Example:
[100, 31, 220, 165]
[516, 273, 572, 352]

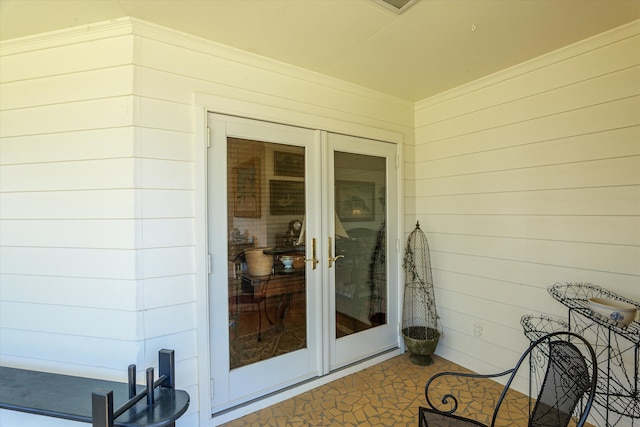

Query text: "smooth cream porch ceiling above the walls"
[0, 0, 640, 101]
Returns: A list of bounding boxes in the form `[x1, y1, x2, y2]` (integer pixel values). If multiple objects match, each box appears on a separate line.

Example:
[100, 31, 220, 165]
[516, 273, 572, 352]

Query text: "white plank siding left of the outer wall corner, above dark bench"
[0, 30, 143, 386]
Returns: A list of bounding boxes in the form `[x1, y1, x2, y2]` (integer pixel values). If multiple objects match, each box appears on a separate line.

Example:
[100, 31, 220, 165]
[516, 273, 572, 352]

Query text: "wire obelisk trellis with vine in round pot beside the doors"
[402, 222, 442, 365]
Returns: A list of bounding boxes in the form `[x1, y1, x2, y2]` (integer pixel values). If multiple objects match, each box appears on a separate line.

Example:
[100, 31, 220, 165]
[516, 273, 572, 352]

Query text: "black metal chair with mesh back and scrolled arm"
[419, 331, 598, 427]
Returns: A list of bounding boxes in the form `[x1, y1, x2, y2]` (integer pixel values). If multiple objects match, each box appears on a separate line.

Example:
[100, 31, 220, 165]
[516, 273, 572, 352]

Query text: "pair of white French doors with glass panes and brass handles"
[207, 114, 398, 413]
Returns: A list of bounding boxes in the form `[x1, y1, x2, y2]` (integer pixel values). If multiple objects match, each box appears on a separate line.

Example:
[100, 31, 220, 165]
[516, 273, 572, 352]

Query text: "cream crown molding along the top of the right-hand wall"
[415, 20, 640, 111]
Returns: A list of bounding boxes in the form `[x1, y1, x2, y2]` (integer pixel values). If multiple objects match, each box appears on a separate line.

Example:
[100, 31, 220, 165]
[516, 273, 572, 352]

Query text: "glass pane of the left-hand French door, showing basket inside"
[227, 138, 307, 370]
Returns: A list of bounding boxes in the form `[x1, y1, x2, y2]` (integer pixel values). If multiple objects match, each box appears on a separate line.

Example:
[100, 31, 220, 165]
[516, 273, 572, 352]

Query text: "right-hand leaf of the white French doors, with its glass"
[324, 133, 399, 370]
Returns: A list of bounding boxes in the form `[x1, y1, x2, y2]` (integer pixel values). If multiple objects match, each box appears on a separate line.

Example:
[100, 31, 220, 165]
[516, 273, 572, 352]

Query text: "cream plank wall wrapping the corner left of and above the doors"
[0, 19, 413, 426]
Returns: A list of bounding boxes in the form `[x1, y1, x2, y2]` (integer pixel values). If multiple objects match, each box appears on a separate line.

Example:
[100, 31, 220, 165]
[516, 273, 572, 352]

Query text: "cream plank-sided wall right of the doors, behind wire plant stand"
[416, 18, 640, 396]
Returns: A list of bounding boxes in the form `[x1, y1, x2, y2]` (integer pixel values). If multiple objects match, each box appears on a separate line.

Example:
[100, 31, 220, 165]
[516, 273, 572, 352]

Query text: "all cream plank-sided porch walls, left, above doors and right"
[0, 11, 640, 425]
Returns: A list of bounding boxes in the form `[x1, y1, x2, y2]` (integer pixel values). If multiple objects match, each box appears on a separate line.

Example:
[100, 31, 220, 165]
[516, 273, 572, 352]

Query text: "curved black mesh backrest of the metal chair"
[492, 332, 598, 427]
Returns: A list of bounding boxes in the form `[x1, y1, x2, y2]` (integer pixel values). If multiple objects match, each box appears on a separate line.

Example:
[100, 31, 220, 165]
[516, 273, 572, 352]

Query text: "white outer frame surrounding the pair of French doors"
[192, 93, 405, 426]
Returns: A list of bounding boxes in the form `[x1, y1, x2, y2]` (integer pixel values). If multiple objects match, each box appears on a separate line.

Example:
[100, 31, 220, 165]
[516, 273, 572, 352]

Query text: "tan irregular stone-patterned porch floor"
[223, 353, 528, 427]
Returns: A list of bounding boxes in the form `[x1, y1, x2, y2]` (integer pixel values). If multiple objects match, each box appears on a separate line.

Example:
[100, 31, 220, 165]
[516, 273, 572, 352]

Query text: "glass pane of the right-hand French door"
[334, 151, 388, 338]
